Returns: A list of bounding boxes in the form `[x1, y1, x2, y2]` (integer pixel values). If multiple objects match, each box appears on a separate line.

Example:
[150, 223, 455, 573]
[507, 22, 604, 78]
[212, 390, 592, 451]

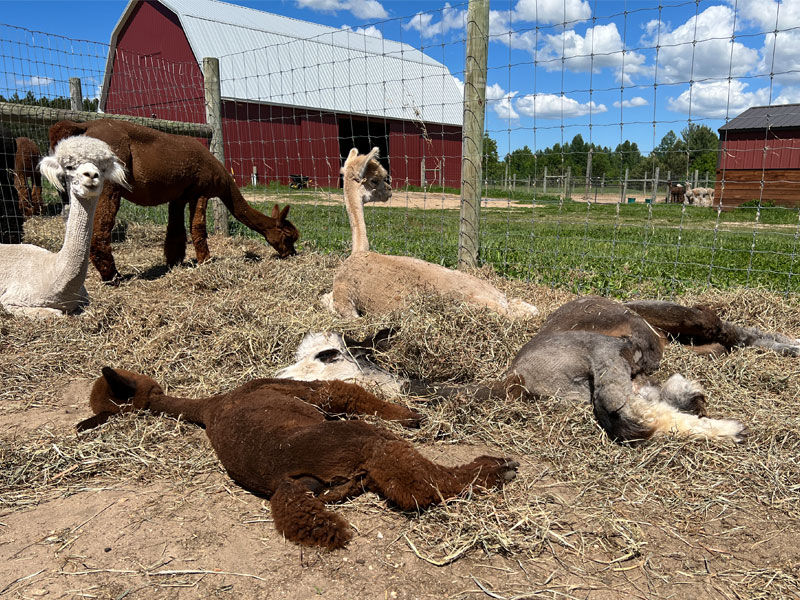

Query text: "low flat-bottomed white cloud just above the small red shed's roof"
[667, 79, 769, 119]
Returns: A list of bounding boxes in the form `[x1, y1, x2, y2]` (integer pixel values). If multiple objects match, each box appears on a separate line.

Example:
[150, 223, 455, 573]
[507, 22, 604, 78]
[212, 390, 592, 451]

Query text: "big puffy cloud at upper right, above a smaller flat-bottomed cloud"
[643, 5, 758, 83]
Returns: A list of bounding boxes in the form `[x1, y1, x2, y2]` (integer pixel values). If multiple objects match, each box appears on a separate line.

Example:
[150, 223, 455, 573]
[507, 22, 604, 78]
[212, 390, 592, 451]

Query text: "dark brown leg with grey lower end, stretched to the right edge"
[625, 301, 800, 356]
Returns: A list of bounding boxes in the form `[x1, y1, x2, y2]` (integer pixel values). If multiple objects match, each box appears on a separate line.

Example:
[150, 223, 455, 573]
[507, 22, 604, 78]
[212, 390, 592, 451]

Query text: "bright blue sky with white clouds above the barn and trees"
[0, 0, 800, 152]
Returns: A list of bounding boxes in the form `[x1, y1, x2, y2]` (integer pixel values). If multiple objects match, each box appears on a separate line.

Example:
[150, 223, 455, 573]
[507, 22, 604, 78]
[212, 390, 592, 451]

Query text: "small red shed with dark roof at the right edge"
[715, 104, 800, 207]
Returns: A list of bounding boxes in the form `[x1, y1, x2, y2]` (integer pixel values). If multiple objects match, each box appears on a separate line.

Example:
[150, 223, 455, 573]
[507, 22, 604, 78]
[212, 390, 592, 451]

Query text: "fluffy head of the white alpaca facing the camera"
[39, 135, 130, 201]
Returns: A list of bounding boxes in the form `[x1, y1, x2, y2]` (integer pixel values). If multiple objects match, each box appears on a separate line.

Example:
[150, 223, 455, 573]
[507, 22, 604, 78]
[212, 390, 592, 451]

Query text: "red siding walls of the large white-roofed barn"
[103, 2, 461, 187]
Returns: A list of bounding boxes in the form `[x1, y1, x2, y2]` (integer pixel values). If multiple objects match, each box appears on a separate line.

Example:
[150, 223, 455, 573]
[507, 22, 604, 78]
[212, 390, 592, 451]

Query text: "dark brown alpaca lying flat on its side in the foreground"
[78, 367, 519, 549]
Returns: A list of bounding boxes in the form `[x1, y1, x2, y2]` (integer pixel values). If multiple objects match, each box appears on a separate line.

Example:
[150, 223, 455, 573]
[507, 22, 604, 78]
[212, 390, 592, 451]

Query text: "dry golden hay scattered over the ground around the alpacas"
[0, 220, 800, 598]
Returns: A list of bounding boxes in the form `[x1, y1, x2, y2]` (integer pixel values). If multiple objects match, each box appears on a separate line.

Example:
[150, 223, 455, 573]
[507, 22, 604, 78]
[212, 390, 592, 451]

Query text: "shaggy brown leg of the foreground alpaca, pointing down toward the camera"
[270, 479, 353, 550]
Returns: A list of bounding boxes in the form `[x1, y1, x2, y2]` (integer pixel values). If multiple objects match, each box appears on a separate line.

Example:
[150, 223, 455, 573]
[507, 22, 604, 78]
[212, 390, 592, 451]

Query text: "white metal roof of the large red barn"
[103, 0, 463, 126]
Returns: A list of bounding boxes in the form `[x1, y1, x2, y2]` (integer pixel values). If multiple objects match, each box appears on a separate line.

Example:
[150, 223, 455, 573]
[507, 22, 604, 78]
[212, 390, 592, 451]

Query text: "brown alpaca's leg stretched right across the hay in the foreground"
[364, 440, 519, 510]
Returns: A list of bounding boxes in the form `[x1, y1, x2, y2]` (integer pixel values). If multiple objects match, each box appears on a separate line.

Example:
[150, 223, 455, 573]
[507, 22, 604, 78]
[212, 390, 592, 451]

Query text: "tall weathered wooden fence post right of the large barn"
[458, 0, 489, 269]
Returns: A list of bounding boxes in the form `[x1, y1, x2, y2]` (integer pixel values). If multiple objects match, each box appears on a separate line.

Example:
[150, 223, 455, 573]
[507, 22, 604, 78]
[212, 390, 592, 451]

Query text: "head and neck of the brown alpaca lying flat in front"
[77, 367, 207, 431]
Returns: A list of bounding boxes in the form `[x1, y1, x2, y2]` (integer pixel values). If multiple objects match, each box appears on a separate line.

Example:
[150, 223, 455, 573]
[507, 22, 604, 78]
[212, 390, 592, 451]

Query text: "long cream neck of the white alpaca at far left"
[53, 194, 97, 294]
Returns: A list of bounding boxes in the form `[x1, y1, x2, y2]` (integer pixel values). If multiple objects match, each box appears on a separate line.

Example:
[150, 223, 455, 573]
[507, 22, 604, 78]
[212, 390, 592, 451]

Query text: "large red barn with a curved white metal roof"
[100, 0, 463, 187]
